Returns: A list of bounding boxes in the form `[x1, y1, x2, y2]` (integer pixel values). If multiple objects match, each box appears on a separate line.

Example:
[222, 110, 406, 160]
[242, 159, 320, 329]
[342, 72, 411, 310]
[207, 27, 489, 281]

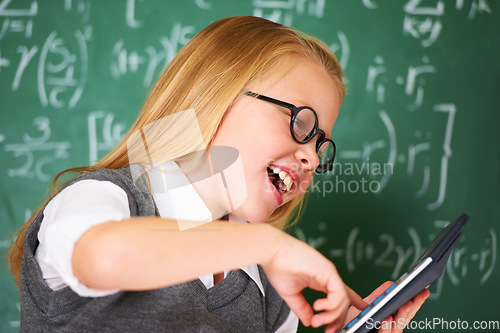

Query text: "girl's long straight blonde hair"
[9, 16, 345, 285]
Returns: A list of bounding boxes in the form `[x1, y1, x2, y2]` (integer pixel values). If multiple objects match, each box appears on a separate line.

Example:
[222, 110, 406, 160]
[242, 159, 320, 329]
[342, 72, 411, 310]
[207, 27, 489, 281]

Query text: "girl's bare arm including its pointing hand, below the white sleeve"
[72, 217, 365, 332]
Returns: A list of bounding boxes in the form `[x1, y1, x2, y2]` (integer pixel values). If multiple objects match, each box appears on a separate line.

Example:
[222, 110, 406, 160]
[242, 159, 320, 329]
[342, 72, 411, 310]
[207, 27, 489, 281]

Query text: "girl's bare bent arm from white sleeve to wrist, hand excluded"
[72, 217, 283, 290]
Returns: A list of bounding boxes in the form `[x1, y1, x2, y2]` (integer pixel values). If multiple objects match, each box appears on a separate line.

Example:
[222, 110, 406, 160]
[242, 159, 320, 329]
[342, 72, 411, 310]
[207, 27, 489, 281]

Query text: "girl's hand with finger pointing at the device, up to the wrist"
[261, 233, 367, 333]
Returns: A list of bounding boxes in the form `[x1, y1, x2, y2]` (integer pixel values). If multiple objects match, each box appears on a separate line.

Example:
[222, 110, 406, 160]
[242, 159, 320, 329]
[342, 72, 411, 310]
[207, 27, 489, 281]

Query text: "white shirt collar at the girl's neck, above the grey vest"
[147, 161, 265, 296]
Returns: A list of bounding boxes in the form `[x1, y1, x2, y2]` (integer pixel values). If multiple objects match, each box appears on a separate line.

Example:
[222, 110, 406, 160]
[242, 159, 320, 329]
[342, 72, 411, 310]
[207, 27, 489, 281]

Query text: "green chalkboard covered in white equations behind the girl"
[0, 0, 500, 332]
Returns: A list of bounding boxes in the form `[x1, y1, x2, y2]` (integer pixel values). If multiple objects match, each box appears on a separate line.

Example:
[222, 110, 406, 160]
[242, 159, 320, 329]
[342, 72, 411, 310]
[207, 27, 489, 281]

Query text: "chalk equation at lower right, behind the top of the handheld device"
[294, 220, 498, 299]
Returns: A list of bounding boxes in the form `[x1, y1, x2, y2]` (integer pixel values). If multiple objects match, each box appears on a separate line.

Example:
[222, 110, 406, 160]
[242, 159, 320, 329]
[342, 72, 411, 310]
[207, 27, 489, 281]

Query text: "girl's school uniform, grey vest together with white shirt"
[20, 162, 298, 332]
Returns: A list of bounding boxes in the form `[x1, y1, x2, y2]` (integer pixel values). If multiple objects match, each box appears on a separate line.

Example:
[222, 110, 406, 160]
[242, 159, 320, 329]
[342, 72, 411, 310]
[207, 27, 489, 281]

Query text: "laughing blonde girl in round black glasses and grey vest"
[10, 17, 428, 332]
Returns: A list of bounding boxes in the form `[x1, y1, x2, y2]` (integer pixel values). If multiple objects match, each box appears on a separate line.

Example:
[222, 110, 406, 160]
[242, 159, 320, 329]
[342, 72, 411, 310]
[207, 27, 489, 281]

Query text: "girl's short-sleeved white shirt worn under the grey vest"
[35, 162, 298, 332]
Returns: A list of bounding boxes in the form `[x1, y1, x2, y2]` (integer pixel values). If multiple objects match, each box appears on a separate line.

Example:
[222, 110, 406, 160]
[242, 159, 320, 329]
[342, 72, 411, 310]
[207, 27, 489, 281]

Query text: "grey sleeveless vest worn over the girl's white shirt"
[21, 165, 290, 333]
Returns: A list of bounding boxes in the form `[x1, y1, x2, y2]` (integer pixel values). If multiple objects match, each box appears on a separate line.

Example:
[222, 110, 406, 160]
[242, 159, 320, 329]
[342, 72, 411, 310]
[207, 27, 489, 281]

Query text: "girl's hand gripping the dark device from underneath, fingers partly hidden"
[344, 281, 430, 333]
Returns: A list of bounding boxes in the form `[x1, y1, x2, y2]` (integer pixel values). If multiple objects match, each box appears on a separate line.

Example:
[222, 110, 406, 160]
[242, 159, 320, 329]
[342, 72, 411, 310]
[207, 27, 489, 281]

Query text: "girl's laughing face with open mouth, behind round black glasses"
[212, 59, 340, 223]
